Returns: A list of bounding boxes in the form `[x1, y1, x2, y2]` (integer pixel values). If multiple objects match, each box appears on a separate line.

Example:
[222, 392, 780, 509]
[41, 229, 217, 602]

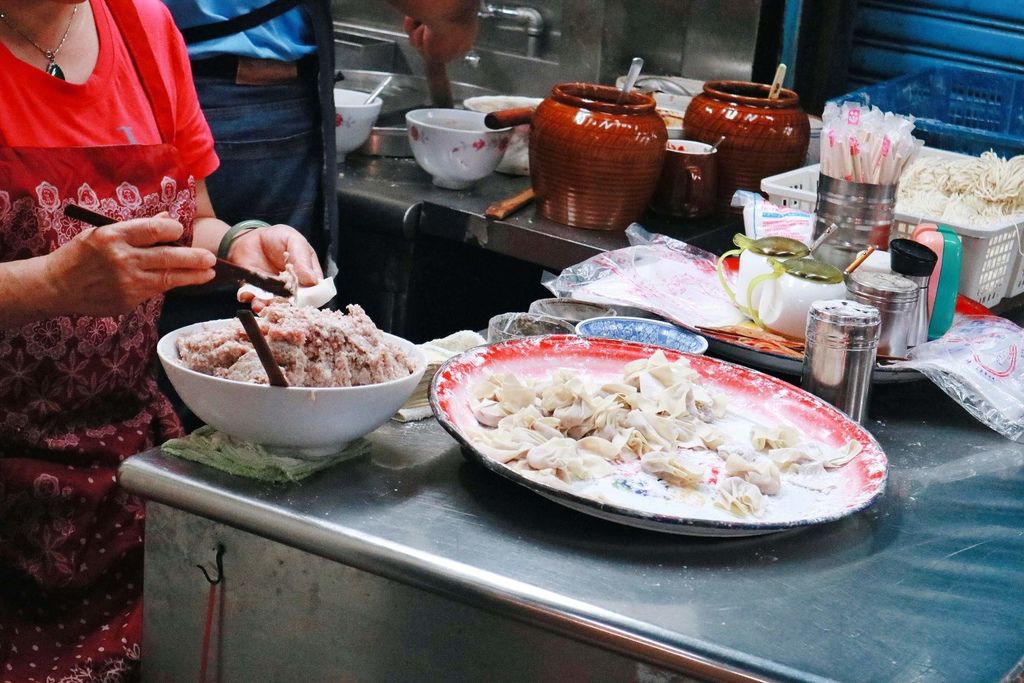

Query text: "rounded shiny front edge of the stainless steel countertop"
[119, 459, 831, 682]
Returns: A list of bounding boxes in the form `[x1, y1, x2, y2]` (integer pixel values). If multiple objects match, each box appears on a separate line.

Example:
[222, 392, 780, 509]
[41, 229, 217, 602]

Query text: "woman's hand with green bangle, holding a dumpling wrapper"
[227, 224, 324, 287]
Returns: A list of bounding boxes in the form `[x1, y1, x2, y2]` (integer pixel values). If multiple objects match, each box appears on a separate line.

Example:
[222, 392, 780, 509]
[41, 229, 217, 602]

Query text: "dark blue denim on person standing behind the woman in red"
[196, 77, 321, 250]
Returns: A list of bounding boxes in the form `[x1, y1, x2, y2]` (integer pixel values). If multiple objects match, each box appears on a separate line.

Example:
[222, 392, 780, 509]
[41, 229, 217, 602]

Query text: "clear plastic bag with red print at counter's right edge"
[895, 315, 1024, 441]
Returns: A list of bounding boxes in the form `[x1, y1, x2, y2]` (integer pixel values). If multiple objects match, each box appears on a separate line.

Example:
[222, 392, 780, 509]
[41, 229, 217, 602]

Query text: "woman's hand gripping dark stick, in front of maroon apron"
[44, 213, 216, 315]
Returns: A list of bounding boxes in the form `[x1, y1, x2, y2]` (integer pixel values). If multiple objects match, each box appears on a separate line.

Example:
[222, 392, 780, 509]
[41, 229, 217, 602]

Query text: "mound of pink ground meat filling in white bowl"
[177, 303, 413, 387]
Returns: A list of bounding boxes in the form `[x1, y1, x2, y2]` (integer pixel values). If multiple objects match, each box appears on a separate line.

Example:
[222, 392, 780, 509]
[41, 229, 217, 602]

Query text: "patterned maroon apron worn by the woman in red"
[0, 0, 196, 682]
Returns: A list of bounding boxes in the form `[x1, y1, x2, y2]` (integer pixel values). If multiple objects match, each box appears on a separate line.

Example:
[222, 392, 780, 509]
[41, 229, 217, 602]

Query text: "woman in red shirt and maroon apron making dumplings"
[0, 0, 321, 682]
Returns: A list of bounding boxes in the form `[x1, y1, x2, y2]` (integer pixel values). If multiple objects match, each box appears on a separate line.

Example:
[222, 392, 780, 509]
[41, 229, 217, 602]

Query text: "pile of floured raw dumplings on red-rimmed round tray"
[468, 351, 860, 517]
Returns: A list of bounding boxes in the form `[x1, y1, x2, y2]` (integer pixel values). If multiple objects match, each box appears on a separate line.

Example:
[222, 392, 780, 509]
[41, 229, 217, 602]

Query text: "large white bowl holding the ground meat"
[157, 321, 427, 458]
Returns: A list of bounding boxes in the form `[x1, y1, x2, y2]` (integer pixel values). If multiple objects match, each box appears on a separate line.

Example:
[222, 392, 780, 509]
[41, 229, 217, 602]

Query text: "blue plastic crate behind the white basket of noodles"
[829, 67, 1024, 157]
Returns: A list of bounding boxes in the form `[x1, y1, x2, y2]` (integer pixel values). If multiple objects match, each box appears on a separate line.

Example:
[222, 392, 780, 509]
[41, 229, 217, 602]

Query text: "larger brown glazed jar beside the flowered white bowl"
[529, 83, 669, 230]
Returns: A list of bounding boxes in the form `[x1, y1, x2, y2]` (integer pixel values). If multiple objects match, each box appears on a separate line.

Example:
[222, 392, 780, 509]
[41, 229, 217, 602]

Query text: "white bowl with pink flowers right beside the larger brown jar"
[406, 109, 512, 189]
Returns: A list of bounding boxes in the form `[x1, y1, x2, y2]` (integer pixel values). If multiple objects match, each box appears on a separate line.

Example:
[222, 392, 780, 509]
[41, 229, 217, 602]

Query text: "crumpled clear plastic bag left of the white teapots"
[543, 223, 745, 328]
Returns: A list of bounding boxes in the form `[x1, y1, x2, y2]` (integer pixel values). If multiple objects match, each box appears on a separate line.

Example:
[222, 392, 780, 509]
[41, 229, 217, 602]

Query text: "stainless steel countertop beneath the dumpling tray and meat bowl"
[121, 374, 1024, 681]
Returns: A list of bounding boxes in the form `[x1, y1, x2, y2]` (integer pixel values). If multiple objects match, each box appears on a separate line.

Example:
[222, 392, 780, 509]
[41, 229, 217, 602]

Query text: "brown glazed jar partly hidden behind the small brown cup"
[684, 81, 811, 212]
